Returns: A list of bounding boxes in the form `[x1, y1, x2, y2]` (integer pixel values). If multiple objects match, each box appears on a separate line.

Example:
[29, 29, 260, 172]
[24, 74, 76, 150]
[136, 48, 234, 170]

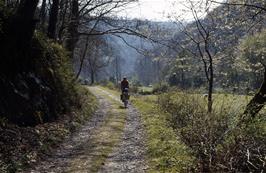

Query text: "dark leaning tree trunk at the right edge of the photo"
[244, 69, 266, 117]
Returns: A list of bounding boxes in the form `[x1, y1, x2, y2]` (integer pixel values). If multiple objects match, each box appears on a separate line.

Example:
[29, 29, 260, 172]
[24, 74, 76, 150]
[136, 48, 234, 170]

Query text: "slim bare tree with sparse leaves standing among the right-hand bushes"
[175, 1, 218, 113]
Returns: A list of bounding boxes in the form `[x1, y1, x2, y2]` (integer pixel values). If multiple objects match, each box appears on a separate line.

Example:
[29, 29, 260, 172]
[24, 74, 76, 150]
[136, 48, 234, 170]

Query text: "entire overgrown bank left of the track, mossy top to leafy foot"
[0, 29, 97, 172]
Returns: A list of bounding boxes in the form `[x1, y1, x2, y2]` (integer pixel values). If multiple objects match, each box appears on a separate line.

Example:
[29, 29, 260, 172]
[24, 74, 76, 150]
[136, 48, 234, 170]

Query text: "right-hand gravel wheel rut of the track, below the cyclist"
[97, 90, 148, 173]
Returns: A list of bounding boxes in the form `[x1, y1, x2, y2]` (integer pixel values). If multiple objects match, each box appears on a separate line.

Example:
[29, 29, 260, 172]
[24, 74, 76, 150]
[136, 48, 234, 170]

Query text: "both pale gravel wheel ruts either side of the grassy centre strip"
[22, 87, 148, 173]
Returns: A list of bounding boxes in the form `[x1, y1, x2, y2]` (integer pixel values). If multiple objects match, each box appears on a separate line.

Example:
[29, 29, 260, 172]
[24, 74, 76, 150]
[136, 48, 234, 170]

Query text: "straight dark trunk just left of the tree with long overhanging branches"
[47, 0, 59, 40]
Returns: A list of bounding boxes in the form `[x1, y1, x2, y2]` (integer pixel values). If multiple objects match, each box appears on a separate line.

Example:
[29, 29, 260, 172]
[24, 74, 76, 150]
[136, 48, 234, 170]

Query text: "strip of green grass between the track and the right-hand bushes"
[132, 96, 194, 172]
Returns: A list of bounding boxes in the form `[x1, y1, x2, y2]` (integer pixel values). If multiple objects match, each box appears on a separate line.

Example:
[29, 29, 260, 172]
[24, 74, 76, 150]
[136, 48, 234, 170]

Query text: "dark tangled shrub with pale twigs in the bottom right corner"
[216, 117, 266, 172]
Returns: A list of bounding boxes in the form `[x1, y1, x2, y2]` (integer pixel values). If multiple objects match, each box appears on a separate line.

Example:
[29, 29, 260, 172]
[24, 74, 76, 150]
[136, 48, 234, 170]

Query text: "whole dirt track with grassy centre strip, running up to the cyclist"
[25, 87, 147, 173]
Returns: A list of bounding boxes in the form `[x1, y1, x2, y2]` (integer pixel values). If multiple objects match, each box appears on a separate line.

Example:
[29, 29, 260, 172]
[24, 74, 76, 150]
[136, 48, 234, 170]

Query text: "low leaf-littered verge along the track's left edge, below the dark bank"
[0, 86, 97, 173]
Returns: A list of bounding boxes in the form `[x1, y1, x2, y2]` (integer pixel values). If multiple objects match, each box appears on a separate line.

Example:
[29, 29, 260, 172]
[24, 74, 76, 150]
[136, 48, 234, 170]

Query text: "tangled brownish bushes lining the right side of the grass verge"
[159, 92, 266, 172]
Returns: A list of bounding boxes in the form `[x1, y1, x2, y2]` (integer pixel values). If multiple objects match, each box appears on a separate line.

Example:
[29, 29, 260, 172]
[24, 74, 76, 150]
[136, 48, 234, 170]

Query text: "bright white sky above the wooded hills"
[118, 0, 222, 21]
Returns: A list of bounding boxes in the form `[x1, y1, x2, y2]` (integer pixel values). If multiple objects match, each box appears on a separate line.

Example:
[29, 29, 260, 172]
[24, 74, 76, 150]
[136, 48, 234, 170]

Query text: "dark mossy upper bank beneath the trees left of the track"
[0, 32, 79, 126]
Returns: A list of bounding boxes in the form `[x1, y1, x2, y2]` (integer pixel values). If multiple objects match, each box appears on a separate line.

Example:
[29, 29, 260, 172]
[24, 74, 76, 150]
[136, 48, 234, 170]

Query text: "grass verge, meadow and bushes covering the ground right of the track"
[103, 84, 266, 172]
